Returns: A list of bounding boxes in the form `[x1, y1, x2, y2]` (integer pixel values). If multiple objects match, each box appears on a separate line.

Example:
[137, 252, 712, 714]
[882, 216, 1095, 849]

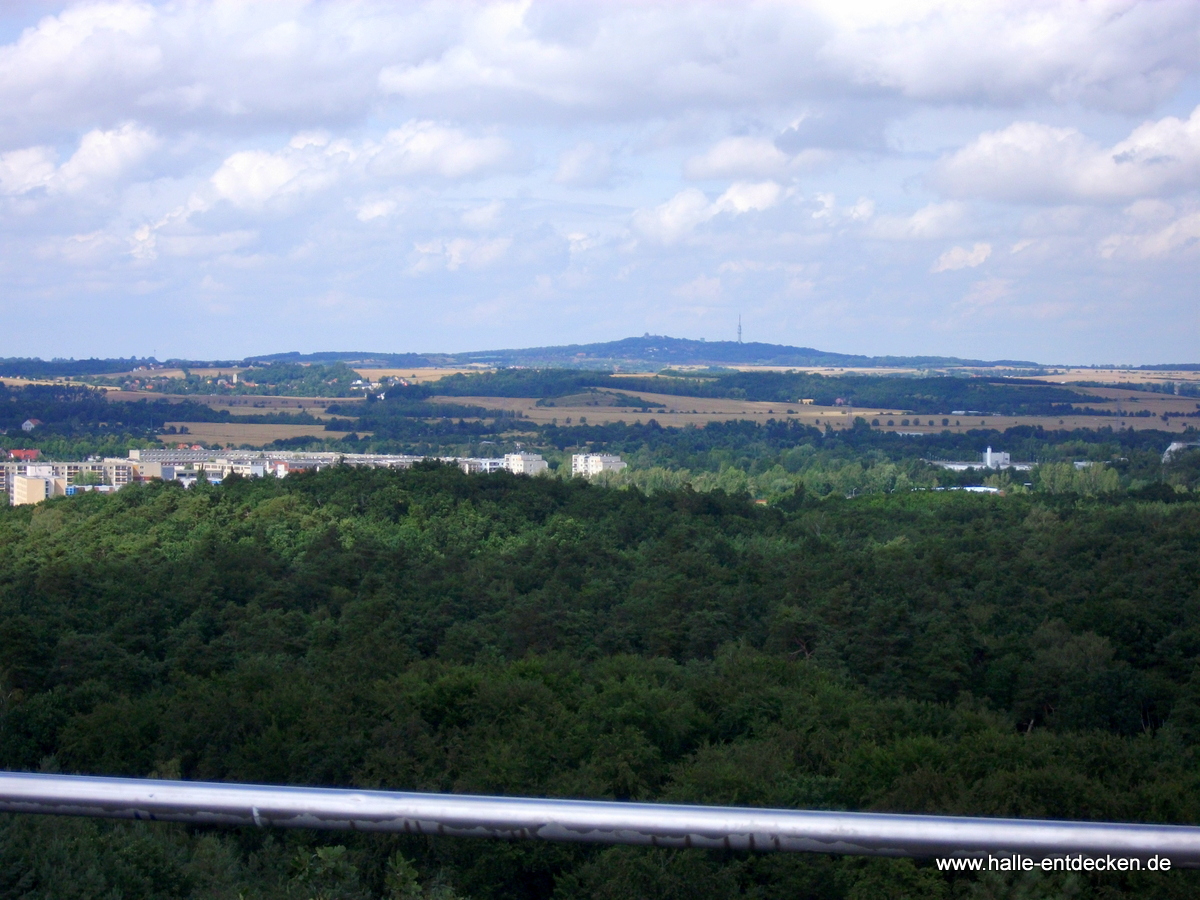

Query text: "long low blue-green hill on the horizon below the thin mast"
[246, 335, 1039, 370]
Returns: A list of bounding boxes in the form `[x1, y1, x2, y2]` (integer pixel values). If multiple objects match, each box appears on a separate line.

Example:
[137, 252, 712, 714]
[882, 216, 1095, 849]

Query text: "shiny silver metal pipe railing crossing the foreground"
[0, 773, 1200, 866]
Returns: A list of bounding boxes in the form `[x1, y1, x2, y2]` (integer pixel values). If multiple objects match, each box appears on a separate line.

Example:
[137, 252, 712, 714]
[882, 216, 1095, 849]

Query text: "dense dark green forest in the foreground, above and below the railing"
[0, 468, 1200, 900]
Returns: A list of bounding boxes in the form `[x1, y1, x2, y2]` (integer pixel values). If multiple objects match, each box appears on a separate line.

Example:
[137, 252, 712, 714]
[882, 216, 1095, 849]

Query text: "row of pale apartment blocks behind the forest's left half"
[0, 448, 625, 505]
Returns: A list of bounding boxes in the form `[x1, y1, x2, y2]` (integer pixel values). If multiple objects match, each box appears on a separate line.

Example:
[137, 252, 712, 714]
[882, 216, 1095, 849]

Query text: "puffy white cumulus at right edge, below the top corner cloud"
[932, 107, 1200, 203]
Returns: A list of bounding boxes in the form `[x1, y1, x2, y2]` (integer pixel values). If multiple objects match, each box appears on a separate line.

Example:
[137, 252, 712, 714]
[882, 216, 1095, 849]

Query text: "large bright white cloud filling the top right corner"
[821, 0, 1200, 110]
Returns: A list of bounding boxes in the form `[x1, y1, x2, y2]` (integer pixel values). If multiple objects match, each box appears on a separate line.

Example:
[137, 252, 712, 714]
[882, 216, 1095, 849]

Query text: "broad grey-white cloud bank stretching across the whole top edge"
[0, 0, 1200, 143]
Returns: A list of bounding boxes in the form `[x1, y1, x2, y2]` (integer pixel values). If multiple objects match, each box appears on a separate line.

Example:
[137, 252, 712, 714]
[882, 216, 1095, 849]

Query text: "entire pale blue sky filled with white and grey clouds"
[0, 0, 1200, 362]
